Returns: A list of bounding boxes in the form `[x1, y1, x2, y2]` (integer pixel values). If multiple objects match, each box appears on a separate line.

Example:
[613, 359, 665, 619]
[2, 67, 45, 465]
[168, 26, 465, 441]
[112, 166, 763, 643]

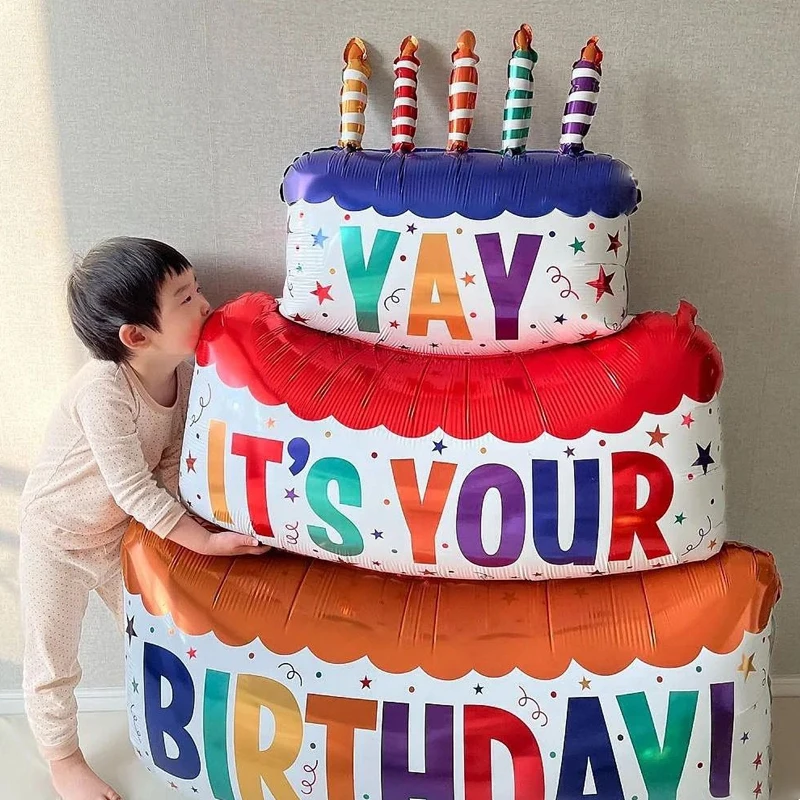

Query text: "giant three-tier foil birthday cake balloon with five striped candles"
[123, 25, 780, 800]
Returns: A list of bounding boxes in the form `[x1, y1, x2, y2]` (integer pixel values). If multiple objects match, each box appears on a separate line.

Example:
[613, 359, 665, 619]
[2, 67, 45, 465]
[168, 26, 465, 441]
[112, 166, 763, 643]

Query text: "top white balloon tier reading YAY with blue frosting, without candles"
[281, 149, 640, 355]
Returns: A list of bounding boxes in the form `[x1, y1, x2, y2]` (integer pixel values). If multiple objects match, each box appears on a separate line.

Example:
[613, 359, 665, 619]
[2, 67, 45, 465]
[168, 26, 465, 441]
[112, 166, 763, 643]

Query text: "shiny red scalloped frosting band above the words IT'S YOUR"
[197, 293, 722, 442]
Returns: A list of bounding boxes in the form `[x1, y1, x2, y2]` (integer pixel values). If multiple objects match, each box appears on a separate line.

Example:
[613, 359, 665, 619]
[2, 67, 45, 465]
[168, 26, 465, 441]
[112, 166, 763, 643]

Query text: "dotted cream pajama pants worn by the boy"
[19, 520, 124, 761]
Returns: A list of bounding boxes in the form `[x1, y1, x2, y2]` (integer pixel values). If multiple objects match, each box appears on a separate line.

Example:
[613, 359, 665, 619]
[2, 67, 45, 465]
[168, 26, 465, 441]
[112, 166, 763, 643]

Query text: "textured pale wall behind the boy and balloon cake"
[0, 0, 800, 691]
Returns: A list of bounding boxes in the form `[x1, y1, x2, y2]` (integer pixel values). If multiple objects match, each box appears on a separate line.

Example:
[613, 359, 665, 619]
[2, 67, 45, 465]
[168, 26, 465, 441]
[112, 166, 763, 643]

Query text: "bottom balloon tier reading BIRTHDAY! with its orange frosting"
[123, 525, 780, 800]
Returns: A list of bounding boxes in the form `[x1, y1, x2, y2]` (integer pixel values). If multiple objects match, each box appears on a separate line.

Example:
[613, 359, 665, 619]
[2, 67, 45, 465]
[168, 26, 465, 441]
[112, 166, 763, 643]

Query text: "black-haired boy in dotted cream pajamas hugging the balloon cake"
[20, 238, 269, 800]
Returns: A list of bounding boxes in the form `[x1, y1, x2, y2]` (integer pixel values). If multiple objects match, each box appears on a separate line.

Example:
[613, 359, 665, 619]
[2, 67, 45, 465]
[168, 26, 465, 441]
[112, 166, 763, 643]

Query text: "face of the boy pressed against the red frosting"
[148, 269, 211, 358]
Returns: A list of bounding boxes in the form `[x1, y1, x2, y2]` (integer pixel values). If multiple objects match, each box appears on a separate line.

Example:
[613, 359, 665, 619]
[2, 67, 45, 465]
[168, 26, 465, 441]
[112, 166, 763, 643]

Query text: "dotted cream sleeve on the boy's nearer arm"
[75, 380, 186, 537]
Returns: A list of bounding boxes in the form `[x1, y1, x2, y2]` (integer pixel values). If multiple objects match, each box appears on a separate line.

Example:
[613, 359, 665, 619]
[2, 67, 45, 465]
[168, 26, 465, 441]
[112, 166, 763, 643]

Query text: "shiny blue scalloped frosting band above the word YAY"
[281, 148, 641, 219]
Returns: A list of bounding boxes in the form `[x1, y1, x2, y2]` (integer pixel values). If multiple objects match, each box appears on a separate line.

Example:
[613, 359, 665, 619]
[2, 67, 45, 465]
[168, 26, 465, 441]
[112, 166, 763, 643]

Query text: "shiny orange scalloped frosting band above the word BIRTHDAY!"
[122, 523, 780, 680]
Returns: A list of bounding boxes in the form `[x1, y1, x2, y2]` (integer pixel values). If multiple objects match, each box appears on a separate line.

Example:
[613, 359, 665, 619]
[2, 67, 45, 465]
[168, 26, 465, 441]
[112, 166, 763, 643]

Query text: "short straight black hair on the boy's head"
[67, 236, 192, 364]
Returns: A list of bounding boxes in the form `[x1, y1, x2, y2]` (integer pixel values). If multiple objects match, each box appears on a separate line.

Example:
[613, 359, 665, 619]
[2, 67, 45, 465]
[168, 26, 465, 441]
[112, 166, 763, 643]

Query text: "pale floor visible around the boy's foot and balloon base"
[0, 698, 800, 800]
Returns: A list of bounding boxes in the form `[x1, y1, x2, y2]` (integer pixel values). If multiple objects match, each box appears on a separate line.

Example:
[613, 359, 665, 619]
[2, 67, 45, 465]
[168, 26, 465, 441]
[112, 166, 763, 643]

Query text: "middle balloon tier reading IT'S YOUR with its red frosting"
[181, 294, 725, 580]
